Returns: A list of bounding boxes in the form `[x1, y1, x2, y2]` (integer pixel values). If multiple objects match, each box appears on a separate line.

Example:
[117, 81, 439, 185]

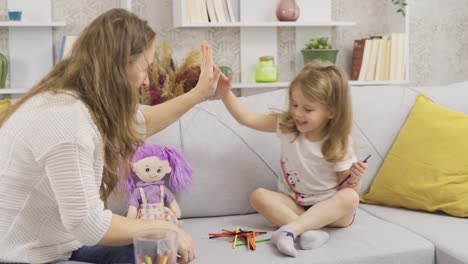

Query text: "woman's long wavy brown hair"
[0, 9, 156, 202]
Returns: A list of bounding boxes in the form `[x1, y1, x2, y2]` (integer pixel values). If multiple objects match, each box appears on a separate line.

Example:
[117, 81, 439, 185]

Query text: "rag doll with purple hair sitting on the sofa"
[125, 144, 192, 224]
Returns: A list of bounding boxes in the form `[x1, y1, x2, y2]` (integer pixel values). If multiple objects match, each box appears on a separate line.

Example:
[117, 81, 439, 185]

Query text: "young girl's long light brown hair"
[279, 61, 352, 162]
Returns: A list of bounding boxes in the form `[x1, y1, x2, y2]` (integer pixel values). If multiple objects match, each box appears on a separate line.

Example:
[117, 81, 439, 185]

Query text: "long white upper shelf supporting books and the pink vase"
[176, 21, 356, 28]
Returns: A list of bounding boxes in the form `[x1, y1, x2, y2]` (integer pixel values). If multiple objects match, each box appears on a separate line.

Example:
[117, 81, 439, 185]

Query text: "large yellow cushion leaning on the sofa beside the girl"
[361, 94, 468, 217]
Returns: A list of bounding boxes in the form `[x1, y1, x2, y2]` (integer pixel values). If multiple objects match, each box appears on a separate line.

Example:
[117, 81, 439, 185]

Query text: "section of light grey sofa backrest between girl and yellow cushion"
[351, 86, 417, 193]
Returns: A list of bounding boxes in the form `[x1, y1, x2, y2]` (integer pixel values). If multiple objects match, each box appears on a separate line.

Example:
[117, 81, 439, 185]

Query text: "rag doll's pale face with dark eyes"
[132, 157, 171, 182]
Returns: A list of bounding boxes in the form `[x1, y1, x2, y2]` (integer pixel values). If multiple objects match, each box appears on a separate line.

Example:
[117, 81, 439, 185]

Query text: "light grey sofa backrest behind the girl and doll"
[110, 83, 468, 217]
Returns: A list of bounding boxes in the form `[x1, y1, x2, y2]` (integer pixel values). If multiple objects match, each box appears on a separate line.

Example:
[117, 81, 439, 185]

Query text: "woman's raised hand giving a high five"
[194, 41, 221, 97]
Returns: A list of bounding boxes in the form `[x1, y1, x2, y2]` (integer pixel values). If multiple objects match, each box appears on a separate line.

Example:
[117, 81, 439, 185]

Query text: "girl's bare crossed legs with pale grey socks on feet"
[250, 188, 359, 257]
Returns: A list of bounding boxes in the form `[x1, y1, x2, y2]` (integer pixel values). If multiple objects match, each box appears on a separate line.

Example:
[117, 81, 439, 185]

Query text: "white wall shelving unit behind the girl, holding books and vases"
[172, 0, 409, 89]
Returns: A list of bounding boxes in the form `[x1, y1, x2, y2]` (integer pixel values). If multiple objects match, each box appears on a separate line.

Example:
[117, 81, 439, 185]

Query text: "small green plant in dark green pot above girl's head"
[302, 37, 338, 64]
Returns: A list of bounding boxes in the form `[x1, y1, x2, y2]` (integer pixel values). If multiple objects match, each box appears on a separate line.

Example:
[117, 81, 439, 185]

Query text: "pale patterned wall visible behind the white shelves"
[0, 0, 468, 85]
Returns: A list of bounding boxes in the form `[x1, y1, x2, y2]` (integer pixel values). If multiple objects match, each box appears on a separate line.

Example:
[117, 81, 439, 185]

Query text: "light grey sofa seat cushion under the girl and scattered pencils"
[182, 210, 434, 264]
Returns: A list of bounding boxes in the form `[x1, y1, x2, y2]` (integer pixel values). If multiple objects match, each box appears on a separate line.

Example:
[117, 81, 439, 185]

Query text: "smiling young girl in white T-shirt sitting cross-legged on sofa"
[217, 62, 367, 257]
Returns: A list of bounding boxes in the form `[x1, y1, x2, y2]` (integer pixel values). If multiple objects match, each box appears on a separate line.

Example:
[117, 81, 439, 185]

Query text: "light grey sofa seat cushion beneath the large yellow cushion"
[360, 204, 468, 264]
